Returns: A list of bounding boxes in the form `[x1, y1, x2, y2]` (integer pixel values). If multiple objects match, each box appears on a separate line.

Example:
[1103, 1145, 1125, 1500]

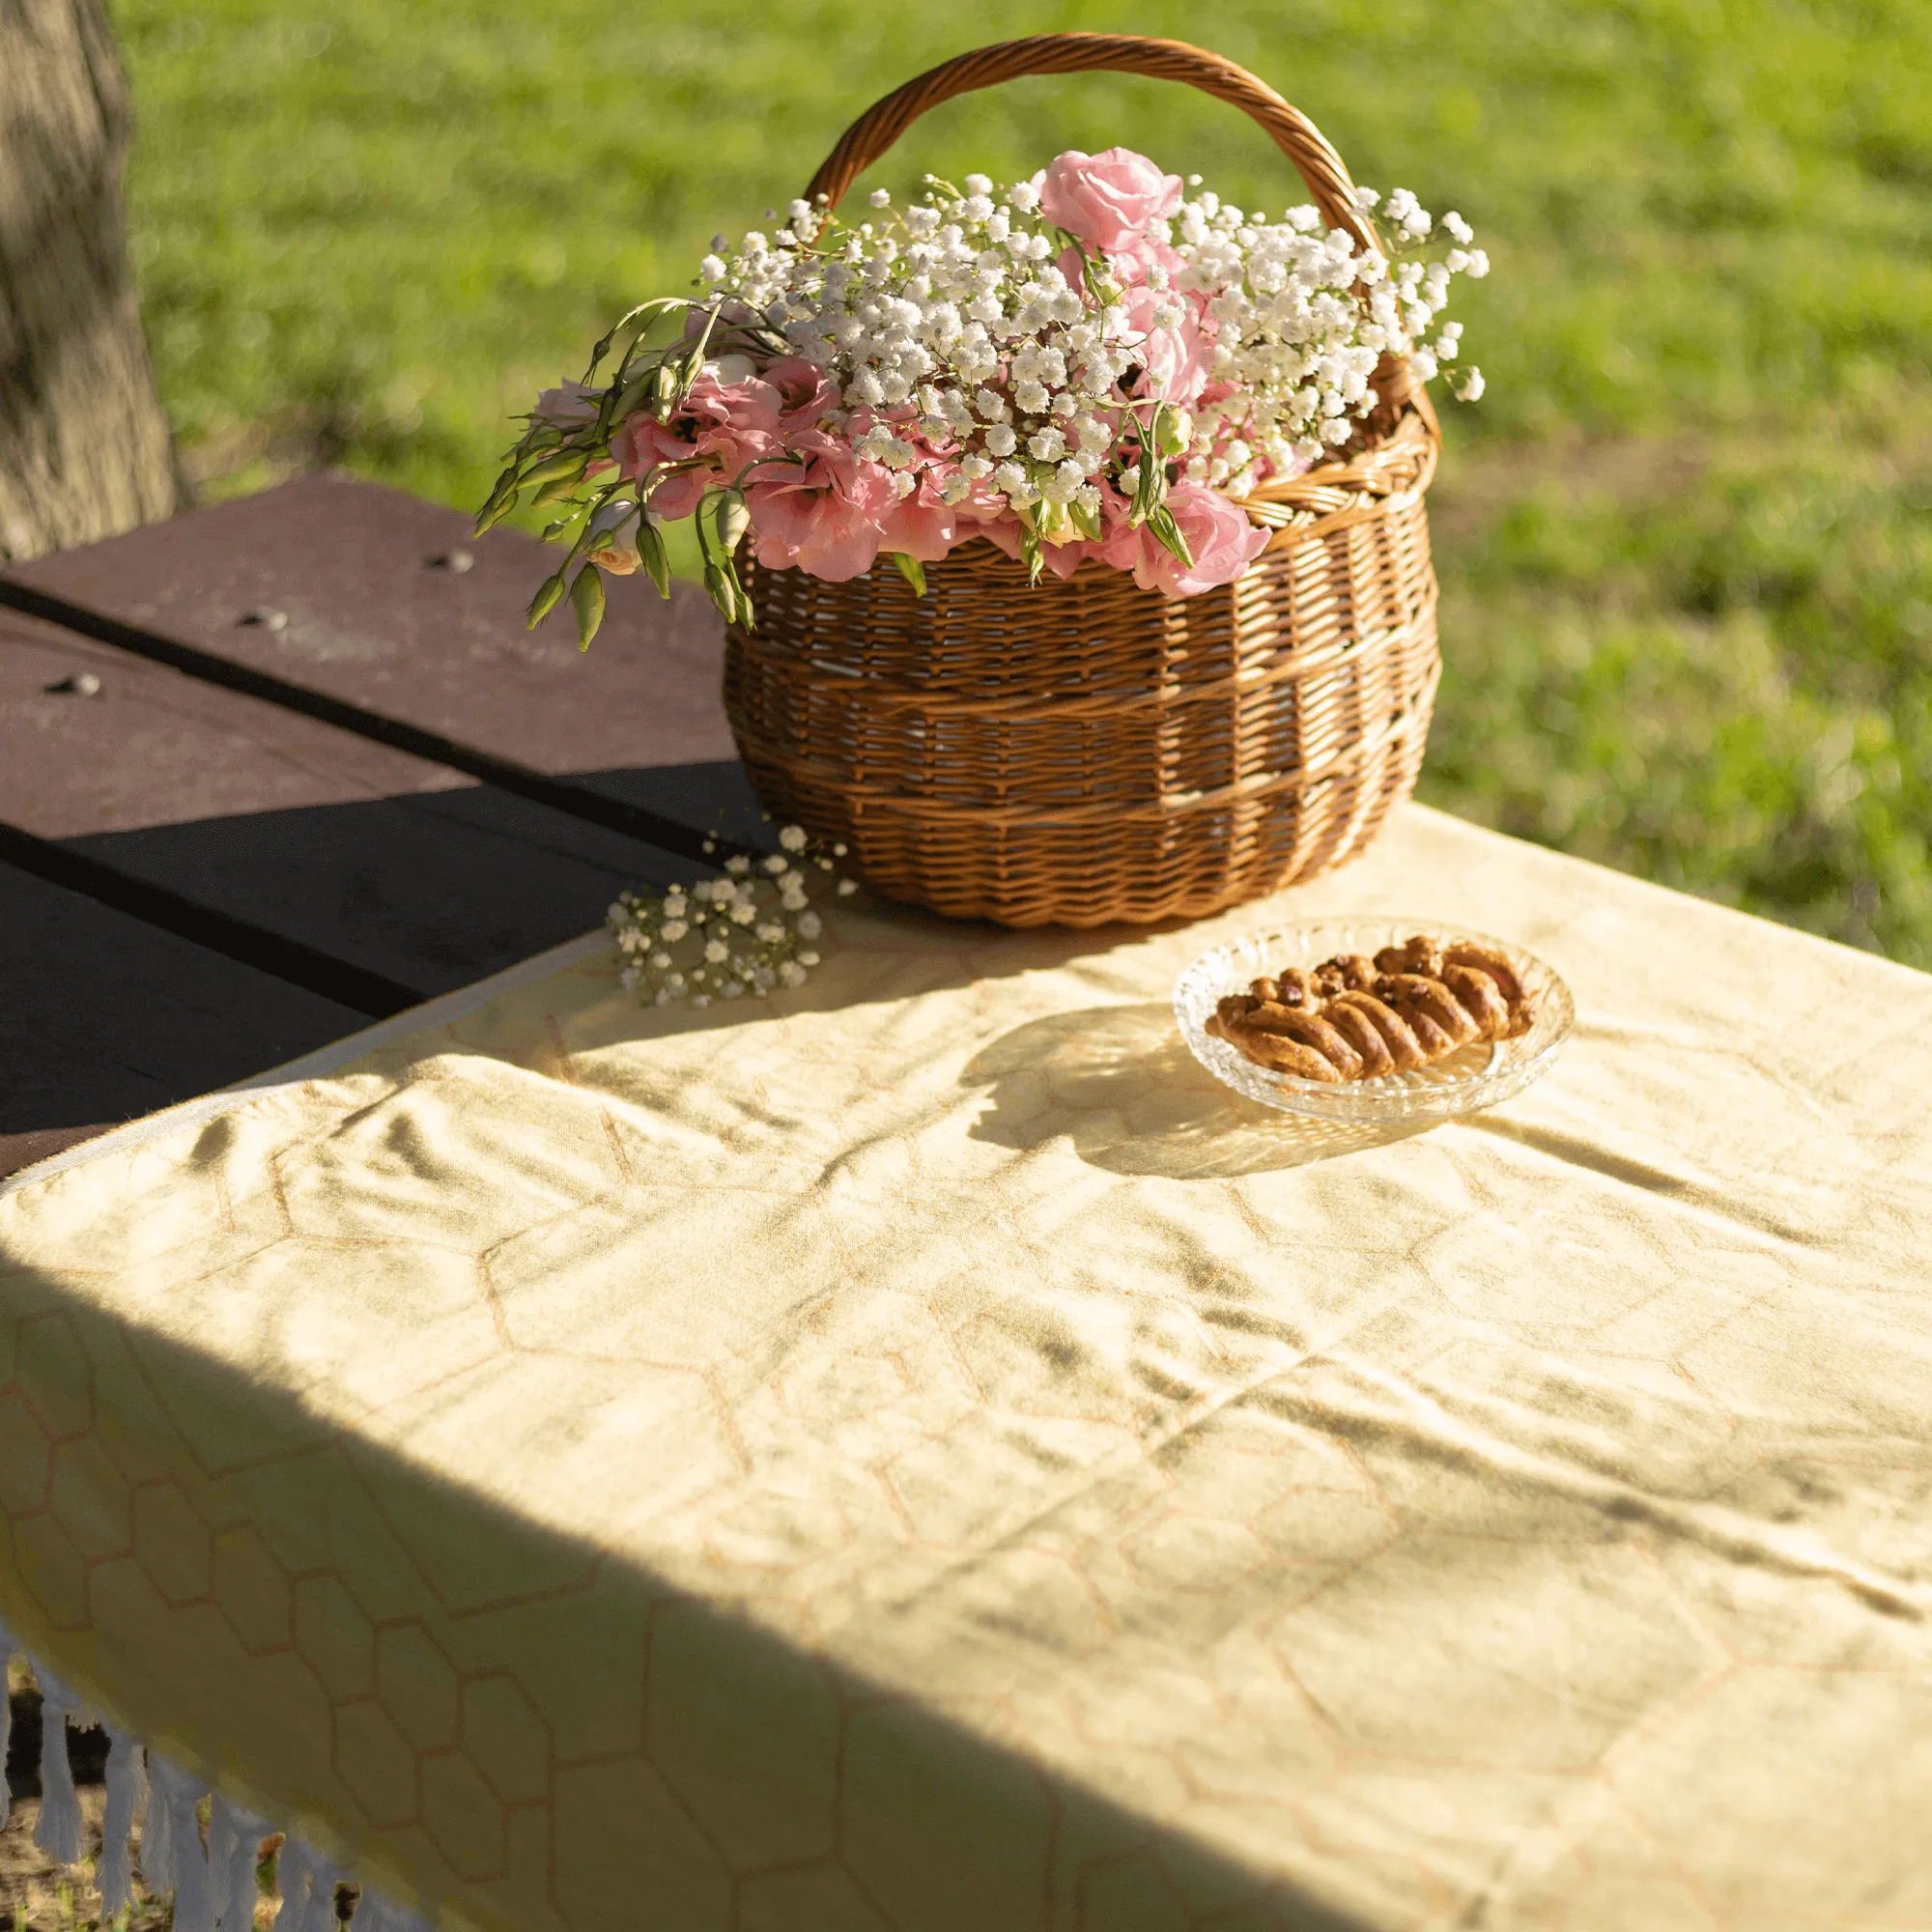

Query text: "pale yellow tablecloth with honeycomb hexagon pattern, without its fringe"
[0, 810, 1932, 1932]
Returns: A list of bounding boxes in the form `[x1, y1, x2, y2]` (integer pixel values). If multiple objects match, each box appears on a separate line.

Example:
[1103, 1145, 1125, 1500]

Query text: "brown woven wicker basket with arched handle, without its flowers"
[724, 33, 1441, 925]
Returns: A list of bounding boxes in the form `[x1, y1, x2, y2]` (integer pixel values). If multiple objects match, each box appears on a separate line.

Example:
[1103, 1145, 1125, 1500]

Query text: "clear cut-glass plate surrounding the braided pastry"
[1175, 918, 1577, 1122]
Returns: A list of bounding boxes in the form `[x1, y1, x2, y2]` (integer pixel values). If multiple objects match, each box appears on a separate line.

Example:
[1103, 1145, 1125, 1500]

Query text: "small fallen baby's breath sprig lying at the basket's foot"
[607, 825, 858, 1007]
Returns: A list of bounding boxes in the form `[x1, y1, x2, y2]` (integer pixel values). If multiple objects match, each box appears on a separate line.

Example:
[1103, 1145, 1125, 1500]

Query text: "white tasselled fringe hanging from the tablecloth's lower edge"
[0, 1623, 433, 1932]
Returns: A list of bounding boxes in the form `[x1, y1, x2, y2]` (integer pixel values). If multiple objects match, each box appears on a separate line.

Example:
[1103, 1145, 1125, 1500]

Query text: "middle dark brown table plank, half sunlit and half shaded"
[0, 611, 701, 1010]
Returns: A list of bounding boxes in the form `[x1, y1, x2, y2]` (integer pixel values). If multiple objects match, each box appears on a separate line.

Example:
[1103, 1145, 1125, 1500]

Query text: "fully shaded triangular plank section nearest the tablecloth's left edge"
[0, 862, 367, 1173]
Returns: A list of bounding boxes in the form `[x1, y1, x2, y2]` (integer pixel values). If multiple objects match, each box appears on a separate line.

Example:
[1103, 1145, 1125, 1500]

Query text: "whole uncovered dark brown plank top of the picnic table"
[0, 475, 746, 1175]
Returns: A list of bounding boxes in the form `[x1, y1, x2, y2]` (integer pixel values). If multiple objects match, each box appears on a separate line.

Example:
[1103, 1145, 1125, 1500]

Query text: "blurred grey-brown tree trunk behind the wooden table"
[0, 0, 178, 560]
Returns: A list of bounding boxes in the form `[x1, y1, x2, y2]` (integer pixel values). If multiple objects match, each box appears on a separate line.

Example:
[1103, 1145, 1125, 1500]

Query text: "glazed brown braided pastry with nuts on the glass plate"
[1208, 933, 1536, 1084]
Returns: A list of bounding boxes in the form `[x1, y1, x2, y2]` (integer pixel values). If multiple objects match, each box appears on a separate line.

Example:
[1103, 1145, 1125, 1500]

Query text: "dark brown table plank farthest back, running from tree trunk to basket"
[0, 475, 757, 850]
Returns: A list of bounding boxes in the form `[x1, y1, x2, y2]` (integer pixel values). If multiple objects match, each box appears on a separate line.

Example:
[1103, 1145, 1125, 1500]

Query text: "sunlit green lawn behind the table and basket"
[116, 0, 1932, 966]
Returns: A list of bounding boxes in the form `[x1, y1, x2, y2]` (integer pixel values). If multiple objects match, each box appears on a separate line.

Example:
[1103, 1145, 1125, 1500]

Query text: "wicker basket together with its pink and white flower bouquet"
[483, 35, 1488, 923]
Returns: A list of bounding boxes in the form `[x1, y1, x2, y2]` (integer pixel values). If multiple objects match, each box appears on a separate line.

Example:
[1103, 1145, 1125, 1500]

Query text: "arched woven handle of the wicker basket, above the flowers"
[806, 33, 1381, 255]
